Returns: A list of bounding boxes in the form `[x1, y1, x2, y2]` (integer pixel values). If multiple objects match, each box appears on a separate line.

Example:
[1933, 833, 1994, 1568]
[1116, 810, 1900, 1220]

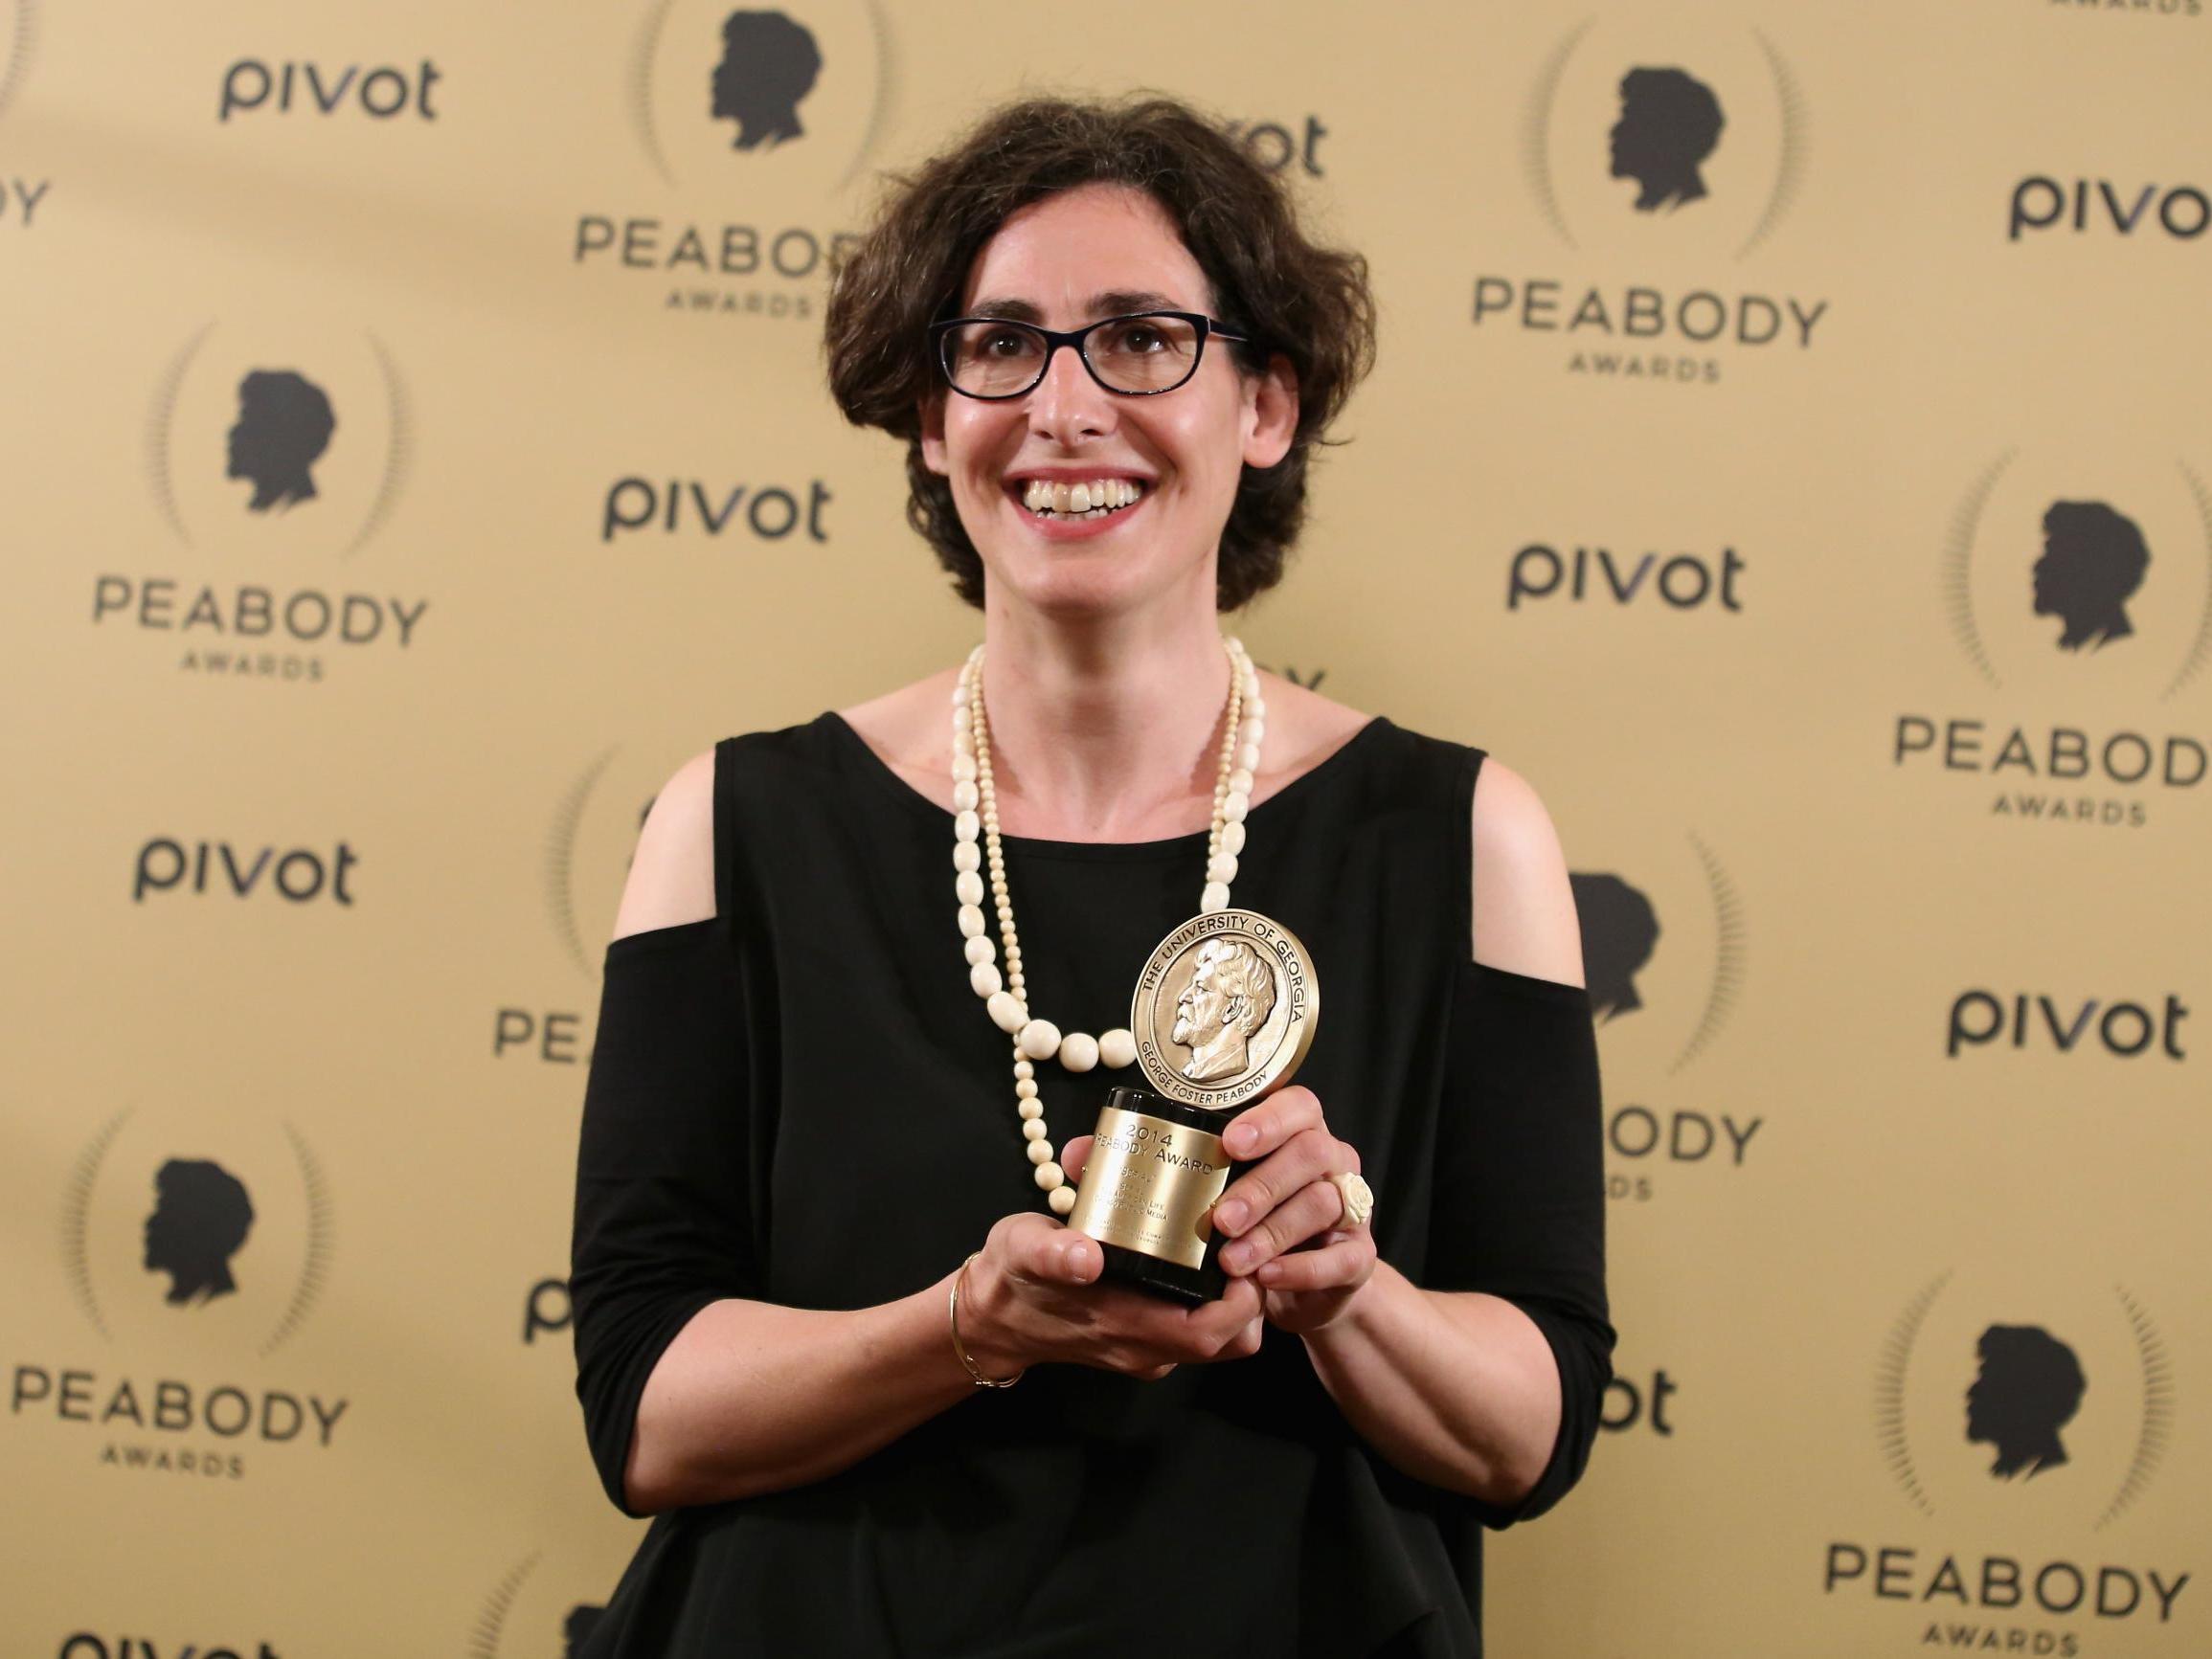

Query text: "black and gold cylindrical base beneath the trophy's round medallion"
[1069, 1087, 1243, 1305]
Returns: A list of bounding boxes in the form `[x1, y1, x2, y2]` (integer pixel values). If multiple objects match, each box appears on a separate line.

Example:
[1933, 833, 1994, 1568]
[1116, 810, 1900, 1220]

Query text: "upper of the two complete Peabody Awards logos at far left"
[91, 323, 429, 684]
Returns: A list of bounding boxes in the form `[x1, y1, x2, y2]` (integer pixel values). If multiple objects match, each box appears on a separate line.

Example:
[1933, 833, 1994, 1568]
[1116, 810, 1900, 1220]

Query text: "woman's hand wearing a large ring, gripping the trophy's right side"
[1214, 1087, 1376, 1332]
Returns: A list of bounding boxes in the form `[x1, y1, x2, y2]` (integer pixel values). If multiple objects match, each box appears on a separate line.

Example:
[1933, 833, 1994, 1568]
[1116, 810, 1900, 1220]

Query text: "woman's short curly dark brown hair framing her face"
[823, 98, 1376, 611]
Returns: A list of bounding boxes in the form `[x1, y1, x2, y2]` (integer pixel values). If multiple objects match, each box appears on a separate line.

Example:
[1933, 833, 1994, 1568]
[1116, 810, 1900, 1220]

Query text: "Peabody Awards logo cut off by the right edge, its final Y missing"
[1891, 449, 2212, 827]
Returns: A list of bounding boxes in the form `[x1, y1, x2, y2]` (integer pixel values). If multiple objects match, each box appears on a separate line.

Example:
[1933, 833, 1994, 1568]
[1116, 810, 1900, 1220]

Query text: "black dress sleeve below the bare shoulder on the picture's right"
[1425, 962, 1613, 1526]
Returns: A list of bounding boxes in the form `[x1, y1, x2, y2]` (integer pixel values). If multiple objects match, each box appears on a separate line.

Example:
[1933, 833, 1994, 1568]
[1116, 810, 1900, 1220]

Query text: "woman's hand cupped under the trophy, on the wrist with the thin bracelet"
[960, 1134, 1268, 1382]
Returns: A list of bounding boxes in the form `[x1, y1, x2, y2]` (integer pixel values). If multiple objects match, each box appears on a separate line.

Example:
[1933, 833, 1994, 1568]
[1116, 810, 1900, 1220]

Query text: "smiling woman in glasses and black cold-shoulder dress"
[573, 101, 1613, 1654]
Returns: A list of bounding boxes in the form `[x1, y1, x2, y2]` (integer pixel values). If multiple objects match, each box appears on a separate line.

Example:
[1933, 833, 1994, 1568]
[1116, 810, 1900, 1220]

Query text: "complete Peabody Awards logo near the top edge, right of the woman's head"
[1473, 17, 1827, 383]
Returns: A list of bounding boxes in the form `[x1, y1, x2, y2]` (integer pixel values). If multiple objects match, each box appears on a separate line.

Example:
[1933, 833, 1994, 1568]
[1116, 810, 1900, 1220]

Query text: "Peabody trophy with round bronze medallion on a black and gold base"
[1069, 909, 1320, 1303]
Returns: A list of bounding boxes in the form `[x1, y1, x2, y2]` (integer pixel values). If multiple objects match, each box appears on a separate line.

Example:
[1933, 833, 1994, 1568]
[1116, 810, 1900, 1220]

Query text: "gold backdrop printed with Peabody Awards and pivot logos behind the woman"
[0, 0, 2212, 1659]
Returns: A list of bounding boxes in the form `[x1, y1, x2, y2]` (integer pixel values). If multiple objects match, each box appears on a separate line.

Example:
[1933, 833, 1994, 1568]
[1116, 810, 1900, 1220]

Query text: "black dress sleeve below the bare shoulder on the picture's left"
[569, 918, 758, 1515]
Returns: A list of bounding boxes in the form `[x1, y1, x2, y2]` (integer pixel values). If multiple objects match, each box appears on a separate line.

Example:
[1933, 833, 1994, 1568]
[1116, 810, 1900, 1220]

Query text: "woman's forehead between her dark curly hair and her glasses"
[960, 184, 1208, 321]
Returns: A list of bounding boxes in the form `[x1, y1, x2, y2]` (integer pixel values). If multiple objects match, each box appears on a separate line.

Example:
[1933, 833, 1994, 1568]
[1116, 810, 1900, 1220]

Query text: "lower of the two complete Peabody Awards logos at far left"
[9, 1110, 350, 1480]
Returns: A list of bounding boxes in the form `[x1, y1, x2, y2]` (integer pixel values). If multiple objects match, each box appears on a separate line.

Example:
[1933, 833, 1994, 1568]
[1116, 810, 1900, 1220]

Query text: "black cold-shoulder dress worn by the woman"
[573, 714, 1613, 1659]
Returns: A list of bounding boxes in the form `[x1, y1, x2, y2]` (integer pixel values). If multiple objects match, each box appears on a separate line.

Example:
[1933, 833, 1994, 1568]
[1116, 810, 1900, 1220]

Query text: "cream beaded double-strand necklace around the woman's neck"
[954, 639, 1268, 1215]
